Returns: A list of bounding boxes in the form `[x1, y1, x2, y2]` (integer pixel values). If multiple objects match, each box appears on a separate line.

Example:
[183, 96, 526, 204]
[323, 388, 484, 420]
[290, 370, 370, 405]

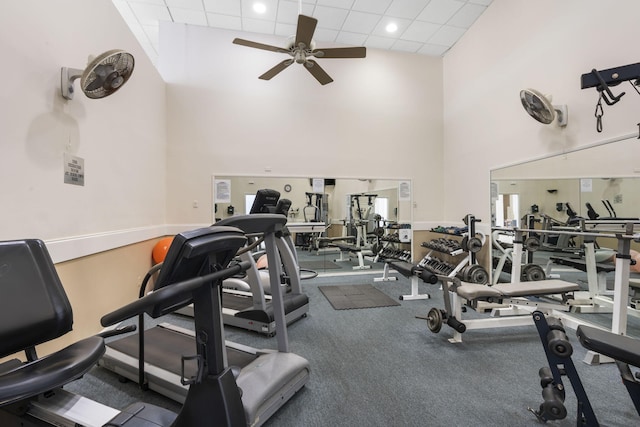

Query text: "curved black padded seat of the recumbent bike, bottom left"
[0, 336, 105, 406]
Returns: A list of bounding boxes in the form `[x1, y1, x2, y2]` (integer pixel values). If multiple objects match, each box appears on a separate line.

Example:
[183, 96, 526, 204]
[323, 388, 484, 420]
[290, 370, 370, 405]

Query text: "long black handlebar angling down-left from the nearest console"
[100, 261, 249, 327]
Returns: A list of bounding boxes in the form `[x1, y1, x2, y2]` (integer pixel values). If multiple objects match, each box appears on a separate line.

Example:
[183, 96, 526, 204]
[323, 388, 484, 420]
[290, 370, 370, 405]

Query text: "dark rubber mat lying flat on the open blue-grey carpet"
[318, 285, 400, 310]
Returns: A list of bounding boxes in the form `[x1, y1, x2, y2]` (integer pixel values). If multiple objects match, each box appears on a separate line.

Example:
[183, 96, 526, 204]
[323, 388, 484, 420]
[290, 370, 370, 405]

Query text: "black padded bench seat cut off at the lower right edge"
[576, 325, 640, 367]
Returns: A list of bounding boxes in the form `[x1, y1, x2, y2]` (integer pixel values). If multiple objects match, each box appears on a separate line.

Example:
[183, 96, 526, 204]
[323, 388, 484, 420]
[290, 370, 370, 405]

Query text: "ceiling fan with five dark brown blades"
[233, 14, 367, 85]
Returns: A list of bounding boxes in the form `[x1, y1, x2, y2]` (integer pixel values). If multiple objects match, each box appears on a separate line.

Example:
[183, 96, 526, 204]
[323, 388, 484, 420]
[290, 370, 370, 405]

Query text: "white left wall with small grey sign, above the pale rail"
[0, 0, 166, 258]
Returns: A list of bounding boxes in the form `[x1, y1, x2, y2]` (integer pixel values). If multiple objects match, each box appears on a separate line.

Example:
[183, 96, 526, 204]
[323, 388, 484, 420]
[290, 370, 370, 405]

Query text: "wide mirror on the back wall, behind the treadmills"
[212, 175, 412, 273]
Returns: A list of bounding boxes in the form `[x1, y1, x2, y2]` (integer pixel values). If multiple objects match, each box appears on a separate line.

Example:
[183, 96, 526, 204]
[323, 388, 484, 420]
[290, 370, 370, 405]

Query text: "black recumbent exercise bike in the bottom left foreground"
[0, 227, 254, 427]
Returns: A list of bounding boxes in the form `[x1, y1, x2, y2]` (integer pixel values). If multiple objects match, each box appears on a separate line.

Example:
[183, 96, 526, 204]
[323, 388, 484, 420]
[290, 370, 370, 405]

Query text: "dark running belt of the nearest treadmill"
[107, 326, 256, 378]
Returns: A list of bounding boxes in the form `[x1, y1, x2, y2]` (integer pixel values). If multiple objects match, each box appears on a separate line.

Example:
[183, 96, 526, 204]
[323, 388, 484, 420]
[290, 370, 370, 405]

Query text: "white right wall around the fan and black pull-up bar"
[443, 0, 640, 224]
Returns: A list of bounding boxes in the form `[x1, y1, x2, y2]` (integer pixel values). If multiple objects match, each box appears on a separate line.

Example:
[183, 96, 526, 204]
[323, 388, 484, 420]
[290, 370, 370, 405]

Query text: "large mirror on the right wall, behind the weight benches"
[491, 135, 640, 300]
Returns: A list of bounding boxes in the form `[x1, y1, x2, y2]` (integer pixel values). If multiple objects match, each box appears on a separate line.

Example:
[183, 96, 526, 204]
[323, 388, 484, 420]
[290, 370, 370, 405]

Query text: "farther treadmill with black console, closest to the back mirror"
[178, 189, 309, 336]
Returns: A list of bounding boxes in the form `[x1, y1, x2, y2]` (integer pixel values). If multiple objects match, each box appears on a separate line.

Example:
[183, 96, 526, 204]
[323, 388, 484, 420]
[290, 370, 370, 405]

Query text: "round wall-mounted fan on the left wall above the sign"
[60, 49, 135, 99]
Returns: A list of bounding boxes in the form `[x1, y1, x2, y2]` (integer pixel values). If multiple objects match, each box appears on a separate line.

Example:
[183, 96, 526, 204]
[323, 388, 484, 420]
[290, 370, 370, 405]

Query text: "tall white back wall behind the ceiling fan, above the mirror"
[160, 24, 443, 227]
